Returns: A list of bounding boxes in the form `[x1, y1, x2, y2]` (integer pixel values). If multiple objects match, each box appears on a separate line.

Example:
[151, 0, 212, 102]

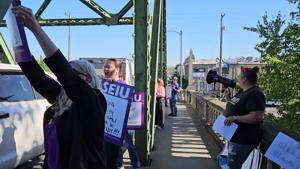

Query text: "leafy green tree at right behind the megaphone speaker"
[245, 0, 300, 132]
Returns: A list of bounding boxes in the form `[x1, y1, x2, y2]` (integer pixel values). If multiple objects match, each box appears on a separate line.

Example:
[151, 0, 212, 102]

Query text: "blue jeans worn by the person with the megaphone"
[227, 142, 257, 169]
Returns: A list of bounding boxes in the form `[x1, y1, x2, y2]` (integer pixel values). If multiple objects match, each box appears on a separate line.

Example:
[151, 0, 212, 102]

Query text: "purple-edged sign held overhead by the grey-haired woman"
[6, 0, 33, 63]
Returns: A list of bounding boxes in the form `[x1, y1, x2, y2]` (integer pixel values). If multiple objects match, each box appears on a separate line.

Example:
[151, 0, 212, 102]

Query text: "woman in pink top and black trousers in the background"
[155, 79, 166, 128]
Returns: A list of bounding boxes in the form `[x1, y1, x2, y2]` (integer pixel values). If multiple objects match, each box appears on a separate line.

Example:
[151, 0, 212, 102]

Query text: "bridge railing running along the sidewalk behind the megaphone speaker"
[184, 90, 300, 169]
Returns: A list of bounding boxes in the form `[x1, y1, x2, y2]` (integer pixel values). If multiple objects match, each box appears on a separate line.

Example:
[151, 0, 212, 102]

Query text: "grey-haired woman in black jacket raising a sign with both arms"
[9, 6, 107, 169]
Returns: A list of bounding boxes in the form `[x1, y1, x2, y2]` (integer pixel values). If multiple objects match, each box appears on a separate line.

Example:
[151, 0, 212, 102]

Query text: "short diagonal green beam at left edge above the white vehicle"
[0, 32, 15, 64]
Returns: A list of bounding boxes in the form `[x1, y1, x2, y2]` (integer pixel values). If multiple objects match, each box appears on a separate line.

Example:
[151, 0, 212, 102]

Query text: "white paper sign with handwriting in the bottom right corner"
[265, 132, 300, 169]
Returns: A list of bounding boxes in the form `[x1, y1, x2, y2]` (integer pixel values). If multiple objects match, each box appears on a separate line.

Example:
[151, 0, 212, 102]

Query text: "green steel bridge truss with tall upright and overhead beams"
[0, 0, 167, 165]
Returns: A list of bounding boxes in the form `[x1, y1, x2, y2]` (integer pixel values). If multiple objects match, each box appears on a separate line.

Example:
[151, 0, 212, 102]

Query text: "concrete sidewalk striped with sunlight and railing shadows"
[126, 104, 219, 169]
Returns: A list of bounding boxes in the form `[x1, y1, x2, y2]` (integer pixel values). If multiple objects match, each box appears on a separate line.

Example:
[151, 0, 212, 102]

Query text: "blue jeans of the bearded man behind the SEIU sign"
[118, 130, 141, 169]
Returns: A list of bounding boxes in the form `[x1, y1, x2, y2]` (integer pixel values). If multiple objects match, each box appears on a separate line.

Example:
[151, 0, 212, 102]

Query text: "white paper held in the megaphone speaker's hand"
[213, 114, 238, 140]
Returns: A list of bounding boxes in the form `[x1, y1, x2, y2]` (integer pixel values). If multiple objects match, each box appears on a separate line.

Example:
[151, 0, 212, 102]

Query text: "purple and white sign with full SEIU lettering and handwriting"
[101, 79, 134, 145]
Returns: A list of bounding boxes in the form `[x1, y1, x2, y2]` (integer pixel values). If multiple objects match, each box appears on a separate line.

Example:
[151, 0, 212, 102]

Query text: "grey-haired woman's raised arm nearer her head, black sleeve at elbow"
[13, 6, 93, 101]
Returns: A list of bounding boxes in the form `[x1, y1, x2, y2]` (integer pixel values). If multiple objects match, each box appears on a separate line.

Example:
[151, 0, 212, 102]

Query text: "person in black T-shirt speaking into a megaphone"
[224, 67, 265, 169]
